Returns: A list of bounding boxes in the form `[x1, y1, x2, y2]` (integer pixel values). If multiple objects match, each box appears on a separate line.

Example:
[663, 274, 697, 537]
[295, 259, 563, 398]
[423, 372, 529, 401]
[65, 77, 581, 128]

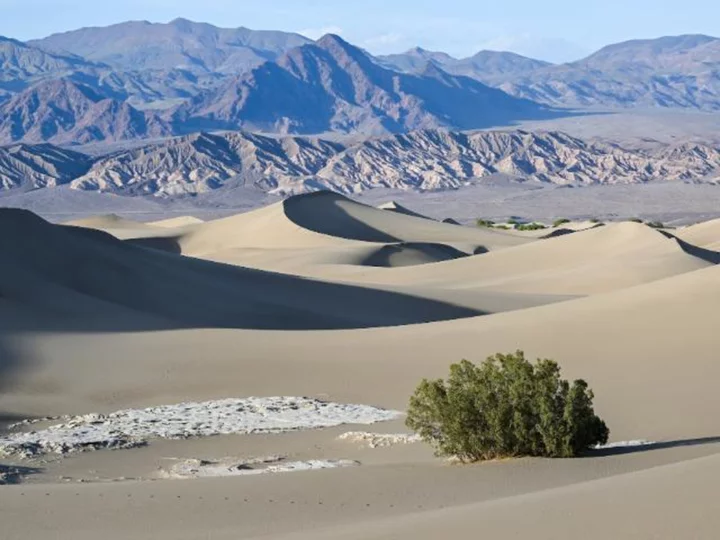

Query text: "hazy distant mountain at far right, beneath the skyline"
[499, 35, 720, 111]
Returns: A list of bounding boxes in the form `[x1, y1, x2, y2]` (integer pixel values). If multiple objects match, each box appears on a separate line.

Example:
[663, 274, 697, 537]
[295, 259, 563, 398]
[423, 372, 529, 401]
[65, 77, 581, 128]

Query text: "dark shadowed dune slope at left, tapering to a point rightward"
[0, 209, 482, 329]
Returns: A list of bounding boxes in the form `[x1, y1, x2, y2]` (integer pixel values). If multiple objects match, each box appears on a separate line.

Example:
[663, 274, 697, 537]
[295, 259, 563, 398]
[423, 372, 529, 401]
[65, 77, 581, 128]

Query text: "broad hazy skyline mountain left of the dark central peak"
[29, 19, 310, 73]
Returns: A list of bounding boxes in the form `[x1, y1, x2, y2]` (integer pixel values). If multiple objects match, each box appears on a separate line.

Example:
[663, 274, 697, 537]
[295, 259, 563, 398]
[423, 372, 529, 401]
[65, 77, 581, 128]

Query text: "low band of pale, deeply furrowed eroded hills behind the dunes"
[0, 130, 720, 196]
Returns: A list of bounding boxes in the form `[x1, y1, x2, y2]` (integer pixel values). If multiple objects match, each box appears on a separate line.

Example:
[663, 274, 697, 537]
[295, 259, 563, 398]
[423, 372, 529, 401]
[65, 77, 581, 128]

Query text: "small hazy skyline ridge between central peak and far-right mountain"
[378, 47, 552, 85]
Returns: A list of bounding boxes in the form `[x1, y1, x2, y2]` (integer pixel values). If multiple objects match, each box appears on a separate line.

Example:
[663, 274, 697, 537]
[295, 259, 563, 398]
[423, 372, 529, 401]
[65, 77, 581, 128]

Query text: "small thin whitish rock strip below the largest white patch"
[162, 456, 360, 478]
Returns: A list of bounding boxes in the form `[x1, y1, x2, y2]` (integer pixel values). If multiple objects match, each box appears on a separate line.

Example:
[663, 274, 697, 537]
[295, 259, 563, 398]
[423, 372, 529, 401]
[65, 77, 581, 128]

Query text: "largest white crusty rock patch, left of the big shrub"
[0, 397, 402, 457]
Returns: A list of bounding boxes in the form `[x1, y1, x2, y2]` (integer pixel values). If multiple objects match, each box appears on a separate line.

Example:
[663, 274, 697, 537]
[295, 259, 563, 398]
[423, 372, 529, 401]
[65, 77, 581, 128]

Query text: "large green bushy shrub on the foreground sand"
[406, 351, 609, 462]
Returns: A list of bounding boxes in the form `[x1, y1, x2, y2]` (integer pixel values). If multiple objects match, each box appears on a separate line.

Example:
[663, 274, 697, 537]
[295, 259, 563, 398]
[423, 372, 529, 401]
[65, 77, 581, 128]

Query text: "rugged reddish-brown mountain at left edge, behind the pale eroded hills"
[0, 79, 172, 144]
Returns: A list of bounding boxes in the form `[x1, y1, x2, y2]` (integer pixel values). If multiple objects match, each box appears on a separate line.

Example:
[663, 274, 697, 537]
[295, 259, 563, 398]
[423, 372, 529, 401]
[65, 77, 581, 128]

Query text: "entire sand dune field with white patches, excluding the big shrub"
[0, 192, 720, 540]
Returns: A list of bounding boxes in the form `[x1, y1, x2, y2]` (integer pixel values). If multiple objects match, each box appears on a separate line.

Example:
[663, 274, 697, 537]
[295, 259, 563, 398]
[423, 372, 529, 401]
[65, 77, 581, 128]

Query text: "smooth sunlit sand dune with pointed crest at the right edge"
[318, 222, 720, 295]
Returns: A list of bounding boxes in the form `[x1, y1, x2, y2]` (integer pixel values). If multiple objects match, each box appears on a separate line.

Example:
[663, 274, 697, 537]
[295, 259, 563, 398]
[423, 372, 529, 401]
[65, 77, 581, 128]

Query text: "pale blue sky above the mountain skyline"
[0, 0, 720, 62]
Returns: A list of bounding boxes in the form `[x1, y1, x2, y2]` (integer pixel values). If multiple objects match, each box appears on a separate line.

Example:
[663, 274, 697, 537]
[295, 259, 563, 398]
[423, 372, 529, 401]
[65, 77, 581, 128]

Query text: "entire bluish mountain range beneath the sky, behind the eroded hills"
[0, 19, 720, 145]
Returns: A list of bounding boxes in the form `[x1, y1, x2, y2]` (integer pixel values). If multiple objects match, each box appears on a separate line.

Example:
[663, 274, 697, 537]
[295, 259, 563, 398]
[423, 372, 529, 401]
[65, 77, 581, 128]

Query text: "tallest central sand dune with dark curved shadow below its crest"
[88, 192, 530, 256]
